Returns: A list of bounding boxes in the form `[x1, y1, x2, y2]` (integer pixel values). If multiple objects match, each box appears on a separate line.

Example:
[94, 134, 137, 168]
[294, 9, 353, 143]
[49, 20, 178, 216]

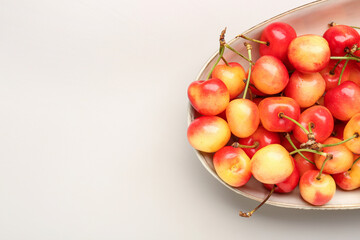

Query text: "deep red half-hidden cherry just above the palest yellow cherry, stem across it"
[238, 126, 280, 158]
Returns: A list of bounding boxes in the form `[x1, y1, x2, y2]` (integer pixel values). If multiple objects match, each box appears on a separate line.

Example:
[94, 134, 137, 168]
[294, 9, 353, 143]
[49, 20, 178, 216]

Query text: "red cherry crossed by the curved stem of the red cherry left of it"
[293, 105, 334, 143]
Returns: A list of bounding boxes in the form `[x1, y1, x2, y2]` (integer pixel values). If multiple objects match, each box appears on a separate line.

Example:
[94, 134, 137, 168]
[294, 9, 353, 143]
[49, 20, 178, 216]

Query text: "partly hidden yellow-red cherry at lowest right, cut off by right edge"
[333, 155, 360, 191]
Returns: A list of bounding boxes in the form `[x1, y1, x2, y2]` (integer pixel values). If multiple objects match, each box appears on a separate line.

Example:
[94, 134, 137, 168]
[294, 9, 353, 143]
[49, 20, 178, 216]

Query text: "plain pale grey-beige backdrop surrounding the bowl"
[0, 0, 360, 240]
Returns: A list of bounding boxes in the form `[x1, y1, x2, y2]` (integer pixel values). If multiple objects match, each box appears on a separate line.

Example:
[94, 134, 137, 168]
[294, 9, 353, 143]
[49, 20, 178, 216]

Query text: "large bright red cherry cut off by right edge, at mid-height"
[324, 81, 360, 121]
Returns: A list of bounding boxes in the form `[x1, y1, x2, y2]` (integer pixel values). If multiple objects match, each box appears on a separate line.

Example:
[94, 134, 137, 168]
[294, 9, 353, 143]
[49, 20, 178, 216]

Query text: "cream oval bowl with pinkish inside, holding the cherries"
[188, 0, 360, 210]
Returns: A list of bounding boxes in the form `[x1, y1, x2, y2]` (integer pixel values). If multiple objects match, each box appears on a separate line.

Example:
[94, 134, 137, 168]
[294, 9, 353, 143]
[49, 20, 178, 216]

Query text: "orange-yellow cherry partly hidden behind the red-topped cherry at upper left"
[212, 62, 246, 99]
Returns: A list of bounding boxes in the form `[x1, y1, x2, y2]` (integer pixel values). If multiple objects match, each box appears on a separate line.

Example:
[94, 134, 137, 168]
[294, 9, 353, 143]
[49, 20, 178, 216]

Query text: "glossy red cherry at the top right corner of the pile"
[323, 25, 360, 56]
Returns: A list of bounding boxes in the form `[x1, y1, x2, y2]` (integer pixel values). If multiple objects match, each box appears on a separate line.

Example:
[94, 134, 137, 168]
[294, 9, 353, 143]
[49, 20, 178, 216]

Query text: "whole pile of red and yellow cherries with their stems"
[187, 22, 360, 217]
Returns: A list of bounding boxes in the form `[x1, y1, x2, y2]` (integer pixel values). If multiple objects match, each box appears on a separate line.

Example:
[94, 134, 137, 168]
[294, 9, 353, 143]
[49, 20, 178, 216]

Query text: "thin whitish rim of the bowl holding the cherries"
[187, 0, 360, 210]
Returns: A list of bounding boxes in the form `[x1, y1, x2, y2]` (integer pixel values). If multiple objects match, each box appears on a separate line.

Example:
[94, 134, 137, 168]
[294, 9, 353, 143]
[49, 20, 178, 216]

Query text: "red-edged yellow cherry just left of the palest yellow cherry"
[213, 146, 251, 187]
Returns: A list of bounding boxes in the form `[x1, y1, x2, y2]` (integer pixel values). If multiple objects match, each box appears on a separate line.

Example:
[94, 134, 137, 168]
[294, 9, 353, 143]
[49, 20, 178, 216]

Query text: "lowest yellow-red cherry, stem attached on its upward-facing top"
[299, 170, 336, 206]
